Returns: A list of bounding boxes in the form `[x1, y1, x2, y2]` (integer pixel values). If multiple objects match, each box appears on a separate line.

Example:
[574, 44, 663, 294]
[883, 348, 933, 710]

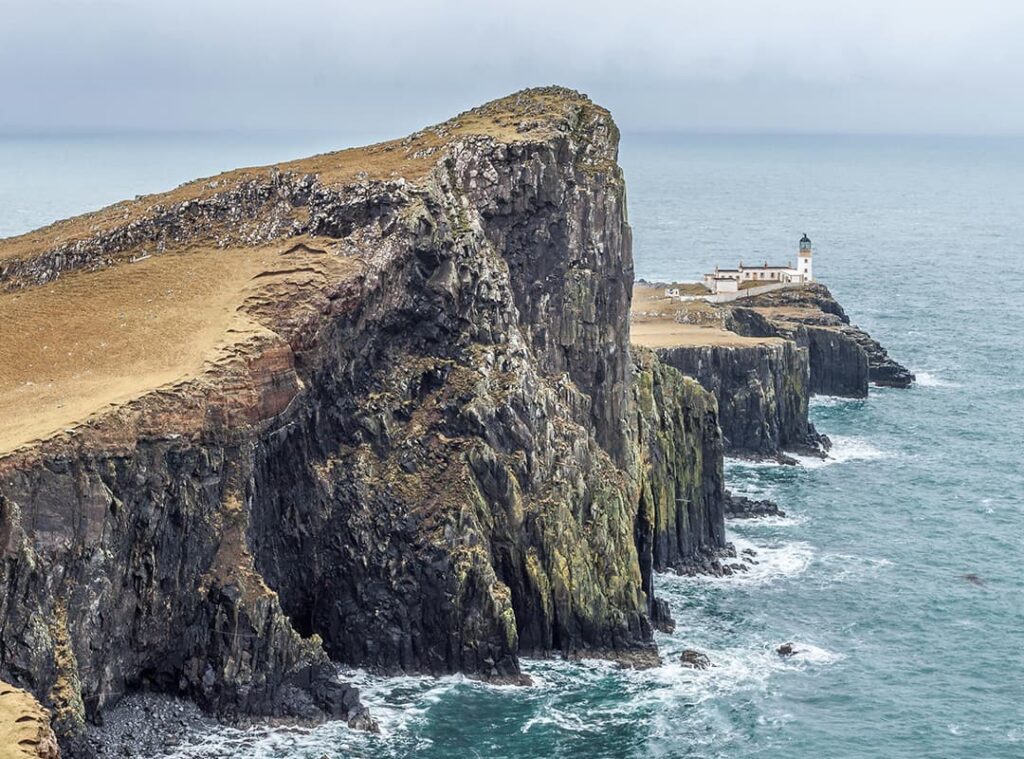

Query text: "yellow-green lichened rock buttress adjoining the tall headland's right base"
[633, 346, 726, 623]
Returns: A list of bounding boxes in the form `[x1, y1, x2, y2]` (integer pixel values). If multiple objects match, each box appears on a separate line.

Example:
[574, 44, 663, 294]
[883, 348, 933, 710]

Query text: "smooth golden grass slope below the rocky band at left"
[0, 239, 358, 453]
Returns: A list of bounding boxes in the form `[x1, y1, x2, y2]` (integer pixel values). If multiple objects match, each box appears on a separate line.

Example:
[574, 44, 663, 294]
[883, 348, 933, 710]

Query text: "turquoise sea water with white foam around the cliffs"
[0, 134, 1024, 759]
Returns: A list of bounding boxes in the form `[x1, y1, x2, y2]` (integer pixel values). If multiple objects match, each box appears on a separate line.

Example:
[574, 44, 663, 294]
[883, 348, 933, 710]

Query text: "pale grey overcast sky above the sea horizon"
[0, 0, 1024, 137]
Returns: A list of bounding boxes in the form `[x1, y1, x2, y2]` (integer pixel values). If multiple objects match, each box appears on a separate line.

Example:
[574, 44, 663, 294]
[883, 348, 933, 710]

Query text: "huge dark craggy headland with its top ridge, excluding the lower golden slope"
[0, 89, 716, 752]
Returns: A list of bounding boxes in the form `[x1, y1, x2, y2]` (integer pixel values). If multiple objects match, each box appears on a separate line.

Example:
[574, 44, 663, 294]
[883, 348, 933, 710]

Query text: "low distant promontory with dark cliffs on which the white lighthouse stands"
[632, 282, 913, 461]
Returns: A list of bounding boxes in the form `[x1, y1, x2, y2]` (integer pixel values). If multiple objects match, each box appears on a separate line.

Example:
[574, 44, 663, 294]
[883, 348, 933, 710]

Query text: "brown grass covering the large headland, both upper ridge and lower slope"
[0, 88, 606, 456]
